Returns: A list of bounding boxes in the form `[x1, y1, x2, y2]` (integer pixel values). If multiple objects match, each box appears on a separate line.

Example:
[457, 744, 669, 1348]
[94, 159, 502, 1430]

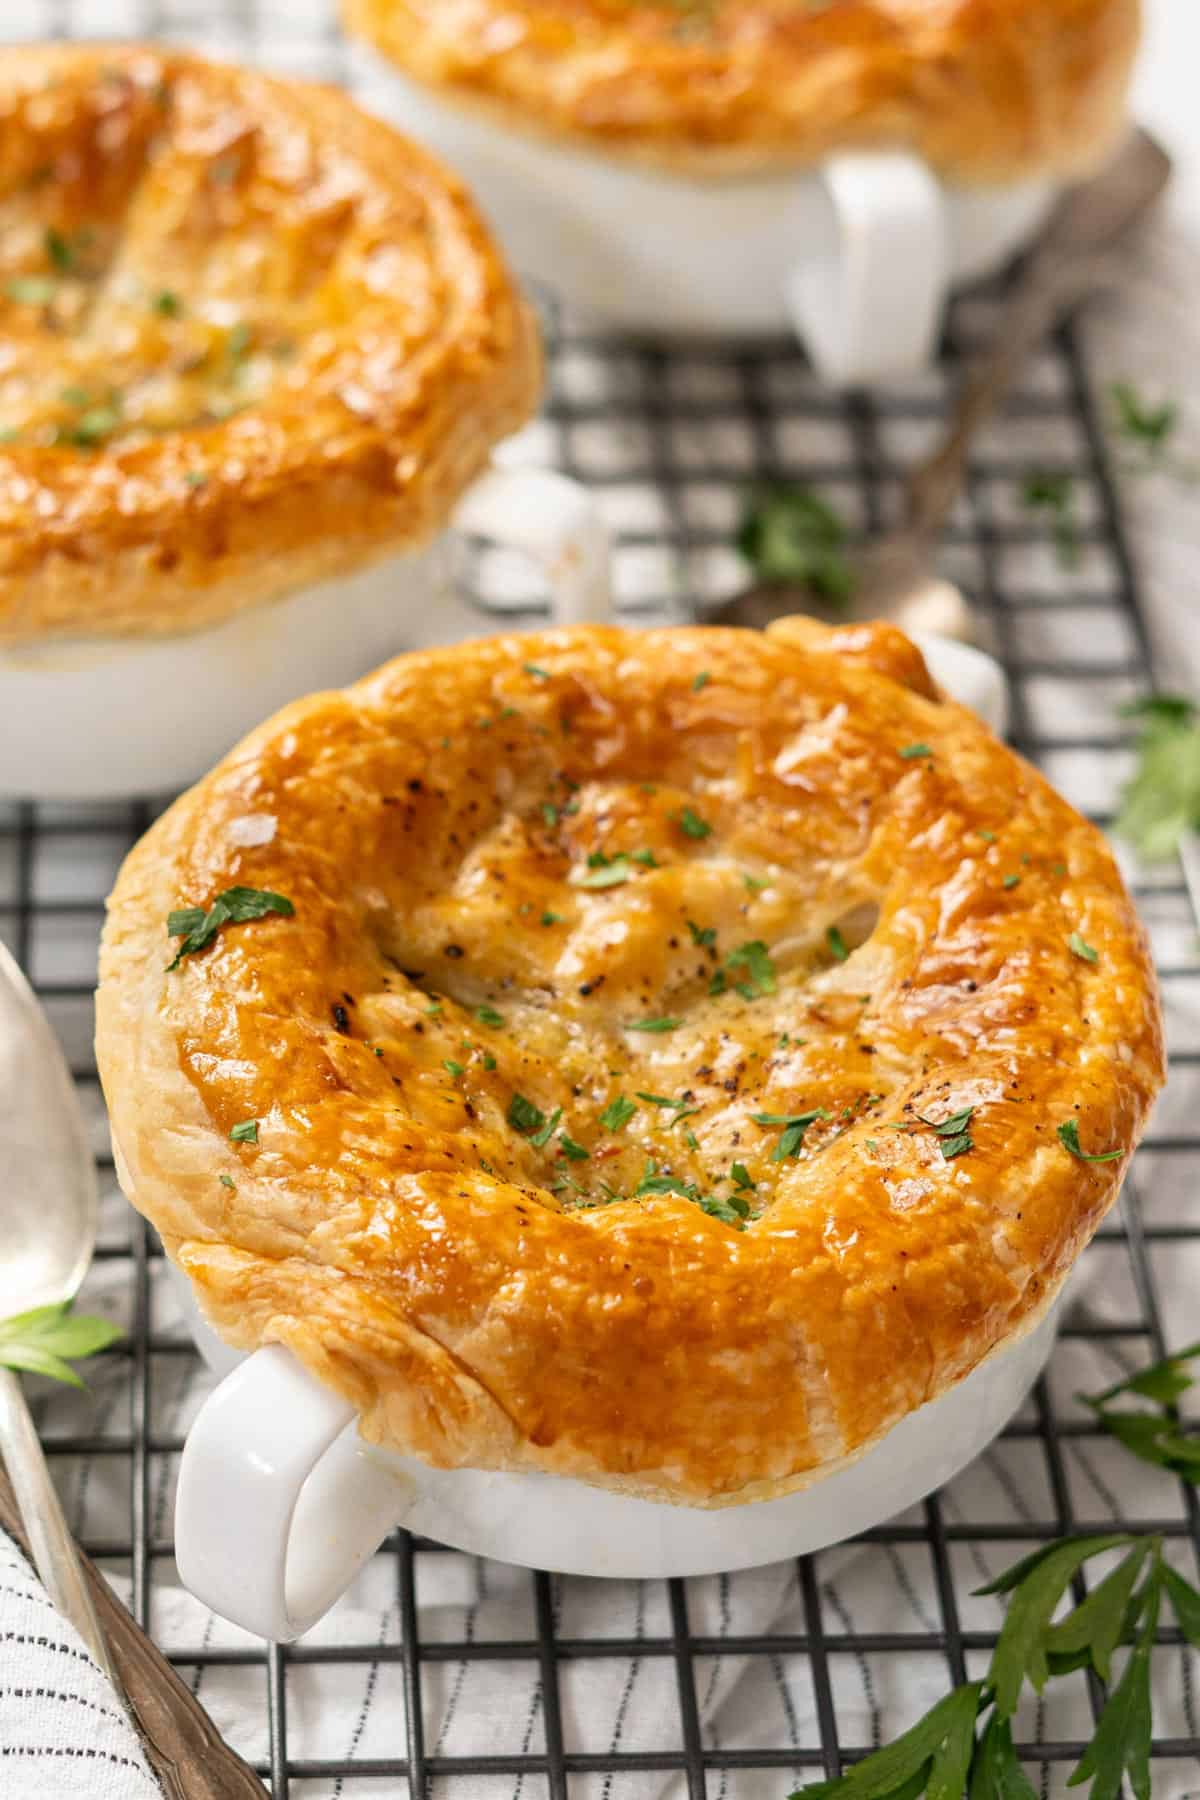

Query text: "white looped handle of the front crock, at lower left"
[175, 1345, 414, 1642]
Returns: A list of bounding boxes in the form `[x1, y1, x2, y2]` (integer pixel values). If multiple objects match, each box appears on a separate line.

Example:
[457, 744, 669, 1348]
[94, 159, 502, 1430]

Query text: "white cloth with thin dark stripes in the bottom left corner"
[0, 1532, 162, 1800]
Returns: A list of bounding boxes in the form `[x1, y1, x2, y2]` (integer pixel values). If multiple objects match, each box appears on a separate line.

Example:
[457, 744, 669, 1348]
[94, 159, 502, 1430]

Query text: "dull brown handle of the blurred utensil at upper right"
[905, 130, 1171, 538]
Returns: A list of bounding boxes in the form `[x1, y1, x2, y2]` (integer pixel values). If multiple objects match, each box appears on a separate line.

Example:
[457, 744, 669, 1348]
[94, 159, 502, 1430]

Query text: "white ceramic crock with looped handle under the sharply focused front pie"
[171, 639, 1036, 1638]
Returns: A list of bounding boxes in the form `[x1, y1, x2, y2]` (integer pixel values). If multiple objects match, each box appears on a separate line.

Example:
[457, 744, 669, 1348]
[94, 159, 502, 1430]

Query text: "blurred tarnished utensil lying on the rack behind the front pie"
[705, 130, 1171, 641]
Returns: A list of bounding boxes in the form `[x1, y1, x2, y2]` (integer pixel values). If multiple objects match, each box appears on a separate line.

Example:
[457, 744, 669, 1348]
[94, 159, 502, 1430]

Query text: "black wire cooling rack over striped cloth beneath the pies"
[0, 0, 1200, 1800]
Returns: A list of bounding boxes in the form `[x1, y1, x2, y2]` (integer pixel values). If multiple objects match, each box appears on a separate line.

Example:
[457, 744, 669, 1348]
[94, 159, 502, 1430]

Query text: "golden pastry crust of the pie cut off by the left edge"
[0, 45, 540, 644]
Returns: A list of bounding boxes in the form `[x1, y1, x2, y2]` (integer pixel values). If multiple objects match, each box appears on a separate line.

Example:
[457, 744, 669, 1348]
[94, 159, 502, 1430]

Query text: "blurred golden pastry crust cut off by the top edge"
[342, 0, 1141, 182]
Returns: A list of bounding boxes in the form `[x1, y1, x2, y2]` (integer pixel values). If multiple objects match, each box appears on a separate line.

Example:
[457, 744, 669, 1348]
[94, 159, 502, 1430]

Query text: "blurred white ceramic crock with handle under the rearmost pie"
[354, 47, 1056, 383]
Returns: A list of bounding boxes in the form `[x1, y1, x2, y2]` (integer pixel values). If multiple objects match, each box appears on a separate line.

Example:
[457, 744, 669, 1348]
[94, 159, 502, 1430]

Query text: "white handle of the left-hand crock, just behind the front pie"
[452, 468, 612, 625]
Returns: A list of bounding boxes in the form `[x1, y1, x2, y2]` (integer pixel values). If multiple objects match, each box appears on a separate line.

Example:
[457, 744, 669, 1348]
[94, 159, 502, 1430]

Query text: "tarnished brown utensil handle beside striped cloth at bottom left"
[0, 1454, 264, 1800]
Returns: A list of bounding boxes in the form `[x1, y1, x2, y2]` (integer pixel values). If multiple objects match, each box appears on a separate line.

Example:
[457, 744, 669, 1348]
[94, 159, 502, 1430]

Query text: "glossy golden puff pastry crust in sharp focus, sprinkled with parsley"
[97, 621, 1162, 1507]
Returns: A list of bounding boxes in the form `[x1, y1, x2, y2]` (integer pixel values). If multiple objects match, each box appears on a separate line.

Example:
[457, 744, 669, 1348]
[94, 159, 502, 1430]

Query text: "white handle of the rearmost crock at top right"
[786, 151, 948, 387]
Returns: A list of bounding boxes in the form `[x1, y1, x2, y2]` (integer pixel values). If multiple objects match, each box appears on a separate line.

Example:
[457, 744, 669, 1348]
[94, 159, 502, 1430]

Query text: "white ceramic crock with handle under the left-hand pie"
[0, 466, 612, 799]
